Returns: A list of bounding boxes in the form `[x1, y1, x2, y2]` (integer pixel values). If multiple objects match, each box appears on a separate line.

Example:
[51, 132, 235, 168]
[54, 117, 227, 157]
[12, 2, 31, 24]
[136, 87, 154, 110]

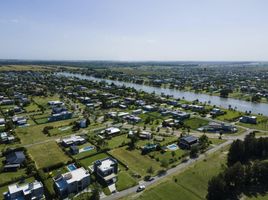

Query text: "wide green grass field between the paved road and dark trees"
[125, 145, 227, 200]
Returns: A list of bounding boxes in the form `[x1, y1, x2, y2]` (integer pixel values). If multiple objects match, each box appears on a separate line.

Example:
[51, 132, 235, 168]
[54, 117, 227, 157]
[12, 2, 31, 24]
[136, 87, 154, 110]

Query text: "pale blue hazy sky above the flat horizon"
[0, 0, 268, 61]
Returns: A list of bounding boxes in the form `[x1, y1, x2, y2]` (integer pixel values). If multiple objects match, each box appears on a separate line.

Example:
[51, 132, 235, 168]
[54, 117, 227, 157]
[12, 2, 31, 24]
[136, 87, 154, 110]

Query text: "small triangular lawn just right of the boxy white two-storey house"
[116, 171, 138, 191]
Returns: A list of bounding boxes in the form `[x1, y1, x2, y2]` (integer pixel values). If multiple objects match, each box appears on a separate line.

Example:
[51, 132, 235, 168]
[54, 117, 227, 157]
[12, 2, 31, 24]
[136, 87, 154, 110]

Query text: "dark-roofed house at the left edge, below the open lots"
[4, 151, 25, 171]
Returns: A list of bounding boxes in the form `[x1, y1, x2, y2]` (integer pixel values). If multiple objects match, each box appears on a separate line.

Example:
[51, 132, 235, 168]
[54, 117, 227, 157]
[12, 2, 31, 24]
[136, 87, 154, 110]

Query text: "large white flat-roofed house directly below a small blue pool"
[53, 167, 90, 198]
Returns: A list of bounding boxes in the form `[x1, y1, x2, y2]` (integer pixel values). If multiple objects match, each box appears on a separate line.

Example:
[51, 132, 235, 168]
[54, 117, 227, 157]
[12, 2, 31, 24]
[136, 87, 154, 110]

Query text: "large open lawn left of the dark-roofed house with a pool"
[110, 147, 161, 176]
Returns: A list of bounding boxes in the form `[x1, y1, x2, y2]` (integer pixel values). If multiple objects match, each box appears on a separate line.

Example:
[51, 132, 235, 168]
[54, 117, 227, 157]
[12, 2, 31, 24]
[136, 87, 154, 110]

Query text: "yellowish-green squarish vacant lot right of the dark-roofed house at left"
[28, 142, 70, 168]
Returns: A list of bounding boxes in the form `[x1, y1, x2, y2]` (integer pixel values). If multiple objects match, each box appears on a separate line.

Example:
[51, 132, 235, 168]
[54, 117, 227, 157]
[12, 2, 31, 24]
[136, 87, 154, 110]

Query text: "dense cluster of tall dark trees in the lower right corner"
[207, 133, 268, 200]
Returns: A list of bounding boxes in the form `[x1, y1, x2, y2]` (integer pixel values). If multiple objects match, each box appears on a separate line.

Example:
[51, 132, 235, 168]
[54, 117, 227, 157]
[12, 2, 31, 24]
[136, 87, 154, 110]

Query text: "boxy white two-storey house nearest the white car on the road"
[93, 157, 118, 185]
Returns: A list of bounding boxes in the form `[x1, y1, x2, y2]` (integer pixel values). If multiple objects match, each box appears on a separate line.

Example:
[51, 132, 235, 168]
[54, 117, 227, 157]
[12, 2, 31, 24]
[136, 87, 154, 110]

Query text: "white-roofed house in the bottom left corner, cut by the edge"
[4, 180, 45, 200]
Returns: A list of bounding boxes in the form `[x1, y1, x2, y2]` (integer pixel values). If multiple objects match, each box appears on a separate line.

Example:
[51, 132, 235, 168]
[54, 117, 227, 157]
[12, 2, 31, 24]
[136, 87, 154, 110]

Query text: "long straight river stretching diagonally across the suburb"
[57, 72, 268, 116]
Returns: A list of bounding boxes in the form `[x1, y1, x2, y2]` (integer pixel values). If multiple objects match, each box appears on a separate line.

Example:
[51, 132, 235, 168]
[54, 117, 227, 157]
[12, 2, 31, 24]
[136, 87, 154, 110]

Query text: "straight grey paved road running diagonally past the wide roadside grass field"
[102, 129, 252, 200]
